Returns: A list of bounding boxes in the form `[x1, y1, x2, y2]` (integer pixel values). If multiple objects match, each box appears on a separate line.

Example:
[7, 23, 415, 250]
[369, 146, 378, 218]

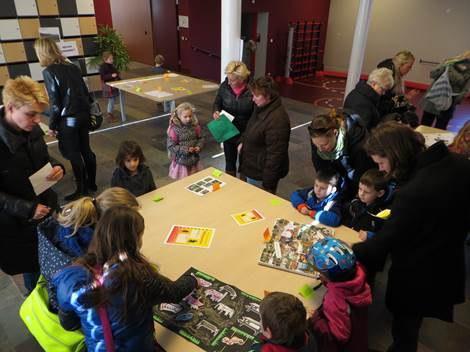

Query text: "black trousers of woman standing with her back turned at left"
[57, 117, 96, 193]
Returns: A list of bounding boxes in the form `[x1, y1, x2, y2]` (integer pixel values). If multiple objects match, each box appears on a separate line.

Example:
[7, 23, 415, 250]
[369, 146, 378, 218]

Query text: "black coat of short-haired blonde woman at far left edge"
[0, 108, 57, 275]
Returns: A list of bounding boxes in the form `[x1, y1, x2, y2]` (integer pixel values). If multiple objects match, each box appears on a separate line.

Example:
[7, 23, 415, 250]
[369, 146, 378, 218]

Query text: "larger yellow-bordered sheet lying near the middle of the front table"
[165, 225, 215, 248]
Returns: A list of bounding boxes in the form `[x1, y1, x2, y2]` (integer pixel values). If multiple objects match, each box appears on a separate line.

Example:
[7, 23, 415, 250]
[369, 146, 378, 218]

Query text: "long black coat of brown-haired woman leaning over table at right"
[353, 142, 470, 320]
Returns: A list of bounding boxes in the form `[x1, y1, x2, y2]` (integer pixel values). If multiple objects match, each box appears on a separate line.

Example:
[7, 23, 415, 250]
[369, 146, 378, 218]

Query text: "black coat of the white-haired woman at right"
[344, 81, 381, 131]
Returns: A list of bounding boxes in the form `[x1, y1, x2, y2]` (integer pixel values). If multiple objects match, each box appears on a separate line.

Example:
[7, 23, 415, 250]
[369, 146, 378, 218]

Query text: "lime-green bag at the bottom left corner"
[20, 276, 86, 352]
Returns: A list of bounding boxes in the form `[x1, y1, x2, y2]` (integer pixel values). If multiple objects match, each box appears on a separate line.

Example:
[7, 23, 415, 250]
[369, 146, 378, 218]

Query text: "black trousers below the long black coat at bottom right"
[387, 313, 423, 352]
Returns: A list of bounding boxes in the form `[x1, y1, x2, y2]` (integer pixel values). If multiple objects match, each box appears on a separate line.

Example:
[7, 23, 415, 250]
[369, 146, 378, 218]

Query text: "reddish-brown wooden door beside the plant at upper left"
[110, 0, 154, 65]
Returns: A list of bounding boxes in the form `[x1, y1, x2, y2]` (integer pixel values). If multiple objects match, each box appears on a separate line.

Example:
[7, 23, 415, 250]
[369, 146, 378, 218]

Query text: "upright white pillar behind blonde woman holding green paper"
[220, 0, 242, 82]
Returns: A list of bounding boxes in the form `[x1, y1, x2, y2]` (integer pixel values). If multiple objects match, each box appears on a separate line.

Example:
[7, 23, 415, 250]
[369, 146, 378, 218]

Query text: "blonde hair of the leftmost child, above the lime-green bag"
[57, 197, 98, 236]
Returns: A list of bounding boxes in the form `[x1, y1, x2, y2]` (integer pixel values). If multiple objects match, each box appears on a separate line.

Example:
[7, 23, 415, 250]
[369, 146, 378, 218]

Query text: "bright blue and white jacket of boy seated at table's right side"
[290, 187, 341, 227]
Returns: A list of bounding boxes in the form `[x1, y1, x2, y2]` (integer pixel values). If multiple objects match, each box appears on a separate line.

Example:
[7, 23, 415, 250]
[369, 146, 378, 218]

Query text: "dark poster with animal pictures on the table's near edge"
[154, 268, 261, 352]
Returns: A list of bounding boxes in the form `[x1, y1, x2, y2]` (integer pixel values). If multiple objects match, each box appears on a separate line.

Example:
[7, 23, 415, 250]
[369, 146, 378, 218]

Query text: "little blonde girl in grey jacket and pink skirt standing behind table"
[167, 103, 204, 179]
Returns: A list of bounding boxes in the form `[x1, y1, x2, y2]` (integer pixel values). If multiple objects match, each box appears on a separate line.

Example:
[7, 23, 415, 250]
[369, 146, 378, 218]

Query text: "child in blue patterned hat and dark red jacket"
[308, 237, 372, 352]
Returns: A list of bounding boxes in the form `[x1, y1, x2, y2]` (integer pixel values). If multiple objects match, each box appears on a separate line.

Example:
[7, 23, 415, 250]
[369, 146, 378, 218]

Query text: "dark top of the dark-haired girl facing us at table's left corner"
[111, 164, 157, 197]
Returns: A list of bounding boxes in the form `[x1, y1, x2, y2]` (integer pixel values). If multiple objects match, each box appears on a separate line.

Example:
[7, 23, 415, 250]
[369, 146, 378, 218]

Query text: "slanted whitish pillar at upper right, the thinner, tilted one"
[344, 0, 373, 98]
